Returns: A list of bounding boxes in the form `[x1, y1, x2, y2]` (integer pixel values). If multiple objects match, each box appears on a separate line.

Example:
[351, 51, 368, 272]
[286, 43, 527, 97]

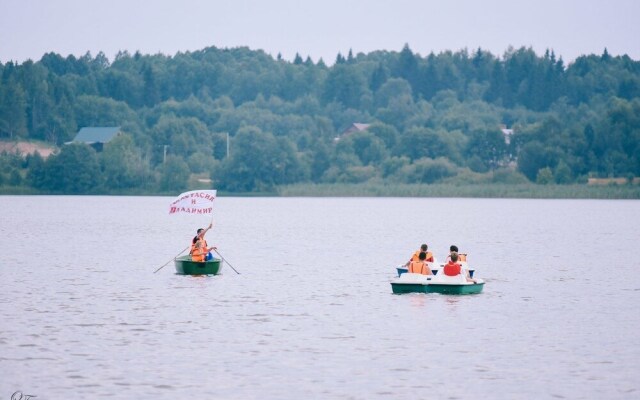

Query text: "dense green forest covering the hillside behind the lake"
[0, 45, 640, 194]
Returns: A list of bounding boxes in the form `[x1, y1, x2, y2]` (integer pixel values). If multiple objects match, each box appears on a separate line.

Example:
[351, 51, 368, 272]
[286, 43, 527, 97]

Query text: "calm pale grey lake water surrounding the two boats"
[0, 196, 640, 400]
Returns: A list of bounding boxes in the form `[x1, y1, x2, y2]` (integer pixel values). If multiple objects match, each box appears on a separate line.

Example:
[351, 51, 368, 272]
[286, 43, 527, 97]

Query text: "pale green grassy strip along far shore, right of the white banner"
[278, 184, 640, 199]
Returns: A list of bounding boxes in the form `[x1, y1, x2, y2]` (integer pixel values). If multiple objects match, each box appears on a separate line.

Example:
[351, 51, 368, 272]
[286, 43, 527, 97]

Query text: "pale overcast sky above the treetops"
[0, 0, 640, 64]
